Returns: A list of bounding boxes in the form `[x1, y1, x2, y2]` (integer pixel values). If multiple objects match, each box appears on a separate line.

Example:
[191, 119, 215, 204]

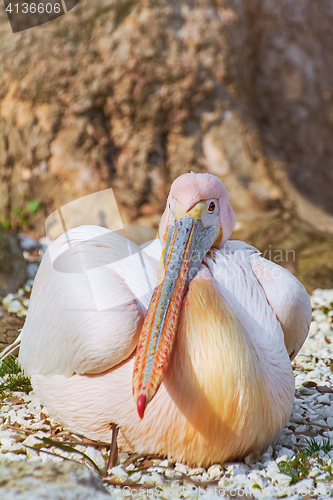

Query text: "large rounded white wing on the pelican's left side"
[19, 226, 161, 376]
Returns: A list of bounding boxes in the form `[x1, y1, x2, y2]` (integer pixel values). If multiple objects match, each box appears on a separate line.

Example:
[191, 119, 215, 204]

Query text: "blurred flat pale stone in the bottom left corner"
[0, 460, 111, 500]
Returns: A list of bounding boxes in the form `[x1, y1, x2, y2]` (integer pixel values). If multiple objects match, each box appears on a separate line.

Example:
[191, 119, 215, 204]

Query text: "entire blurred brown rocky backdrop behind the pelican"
[0, 0, 333, 291]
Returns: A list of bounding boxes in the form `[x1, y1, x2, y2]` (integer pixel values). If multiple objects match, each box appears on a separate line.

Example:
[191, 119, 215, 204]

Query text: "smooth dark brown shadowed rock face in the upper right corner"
[229, 0, 333, 229]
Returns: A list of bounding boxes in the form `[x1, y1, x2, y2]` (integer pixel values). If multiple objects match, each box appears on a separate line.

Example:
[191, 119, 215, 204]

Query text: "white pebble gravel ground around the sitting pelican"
[0, 286, 333, 500]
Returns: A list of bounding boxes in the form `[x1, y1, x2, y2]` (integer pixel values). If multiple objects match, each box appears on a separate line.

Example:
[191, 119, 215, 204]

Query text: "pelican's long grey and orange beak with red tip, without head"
[133, 216, 221, 418]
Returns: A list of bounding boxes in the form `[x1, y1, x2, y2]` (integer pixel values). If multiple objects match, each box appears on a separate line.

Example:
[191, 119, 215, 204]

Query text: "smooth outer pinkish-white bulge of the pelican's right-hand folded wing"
[251, 249, 312, 359]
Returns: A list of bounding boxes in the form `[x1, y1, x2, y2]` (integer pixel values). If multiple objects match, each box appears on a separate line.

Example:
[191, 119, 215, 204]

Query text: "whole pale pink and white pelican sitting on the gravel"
[1, 173, 311, 466]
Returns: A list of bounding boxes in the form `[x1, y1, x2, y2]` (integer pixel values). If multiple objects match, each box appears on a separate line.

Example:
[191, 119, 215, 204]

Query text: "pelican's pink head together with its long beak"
[133, 173, 235, 418]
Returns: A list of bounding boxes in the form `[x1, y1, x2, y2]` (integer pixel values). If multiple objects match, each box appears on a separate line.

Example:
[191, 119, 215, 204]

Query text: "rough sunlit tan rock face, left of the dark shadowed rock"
[0, 0, 235, 227]
